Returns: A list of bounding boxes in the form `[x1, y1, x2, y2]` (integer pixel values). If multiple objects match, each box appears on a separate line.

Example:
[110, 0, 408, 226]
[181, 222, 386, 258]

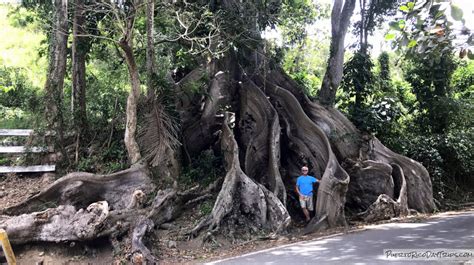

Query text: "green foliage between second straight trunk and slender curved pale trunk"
[65, 43, 130, 174]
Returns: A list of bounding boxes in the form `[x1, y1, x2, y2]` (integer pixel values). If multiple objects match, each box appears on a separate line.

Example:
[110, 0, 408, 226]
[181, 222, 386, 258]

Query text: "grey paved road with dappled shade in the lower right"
[209, 211, 474, 265]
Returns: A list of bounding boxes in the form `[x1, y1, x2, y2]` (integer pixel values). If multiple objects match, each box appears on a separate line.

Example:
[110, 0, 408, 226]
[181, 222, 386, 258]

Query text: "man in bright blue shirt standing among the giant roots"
[296, 167, 318, 222]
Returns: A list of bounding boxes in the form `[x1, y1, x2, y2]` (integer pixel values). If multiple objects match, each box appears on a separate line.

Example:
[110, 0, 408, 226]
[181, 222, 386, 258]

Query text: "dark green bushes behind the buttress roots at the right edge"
[379, 43, 474, 201]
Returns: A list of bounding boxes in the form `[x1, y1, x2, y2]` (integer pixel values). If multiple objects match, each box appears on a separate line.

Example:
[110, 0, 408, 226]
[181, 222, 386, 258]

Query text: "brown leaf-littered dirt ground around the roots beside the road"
[0, 174, 472, 265]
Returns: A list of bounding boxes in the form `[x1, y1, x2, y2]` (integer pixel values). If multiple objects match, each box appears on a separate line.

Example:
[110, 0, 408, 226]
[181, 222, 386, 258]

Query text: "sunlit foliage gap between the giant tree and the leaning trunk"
[273, 0, 330, 98]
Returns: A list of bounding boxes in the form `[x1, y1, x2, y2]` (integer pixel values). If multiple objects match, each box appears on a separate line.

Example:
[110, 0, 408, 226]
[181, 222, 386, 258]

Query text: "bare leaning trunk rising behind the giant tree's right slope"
[318, 0, 356, 106]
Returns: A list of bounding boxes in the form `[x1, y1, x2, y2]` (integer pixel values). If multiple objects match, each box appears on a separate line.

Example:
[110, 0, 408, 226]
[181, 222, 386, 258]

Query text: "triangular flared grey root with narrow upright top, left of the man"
[190, 113, 290, 236]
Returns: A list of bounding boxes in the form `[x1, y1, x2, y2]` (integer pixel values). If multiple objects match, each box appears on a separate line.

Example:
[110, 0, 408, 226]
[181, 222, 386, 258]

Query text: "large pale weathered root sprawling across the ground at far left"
[0, 164, 220, 264]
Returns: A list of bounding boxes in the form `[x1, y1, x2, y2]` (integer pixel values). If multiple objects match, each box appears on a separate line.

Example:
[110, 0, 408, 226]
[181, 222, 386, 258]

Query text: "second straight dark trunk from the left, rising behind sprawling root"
[71, 0, 89, 163]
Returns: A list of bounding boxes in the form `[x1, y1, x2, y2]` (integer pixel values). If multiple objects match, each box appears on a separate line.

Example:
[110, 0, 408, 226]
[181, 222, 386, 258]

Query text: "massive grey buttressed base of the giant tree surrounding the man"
[173, 50, 434, 233]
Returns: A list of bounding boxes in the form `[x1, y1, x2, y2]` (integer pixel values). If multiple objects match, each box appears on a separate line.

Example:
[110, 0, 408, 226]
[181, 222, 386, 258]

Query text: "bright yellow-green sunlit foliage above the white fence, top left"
[0, 5, 46, 128]
